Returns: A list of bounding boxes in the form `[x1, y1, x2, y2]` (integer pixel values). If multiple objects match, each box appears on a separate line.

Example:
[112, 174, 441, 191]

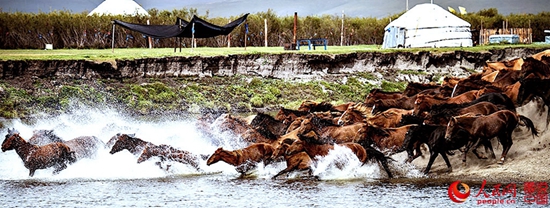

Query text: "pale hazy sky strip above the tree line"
[0, 0, 550, 18]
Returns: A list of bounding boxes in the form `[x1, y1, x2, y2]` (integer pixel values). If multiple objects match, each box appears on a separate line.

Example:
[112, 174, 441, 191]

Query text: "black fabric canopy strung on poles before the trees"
[112, 13, 249, 50]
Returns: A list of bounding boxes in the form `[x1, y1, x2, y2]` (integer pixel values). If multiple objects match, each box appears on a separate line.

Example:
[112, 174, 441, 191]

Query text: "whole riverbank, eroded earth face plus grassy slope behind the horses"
[0, 47, 546, 118]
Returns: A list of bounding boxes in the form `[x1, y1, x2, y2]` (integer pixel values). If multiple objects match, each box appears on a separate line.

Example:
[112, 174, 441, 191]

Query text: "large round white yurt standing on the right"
[382, 3, 472, 48]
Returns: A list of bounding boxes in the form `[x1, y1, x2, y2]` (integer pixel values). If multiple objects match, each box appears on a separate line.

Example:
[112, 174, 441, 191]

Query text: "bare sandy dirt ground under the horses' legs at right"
[413, 98, 550, 183]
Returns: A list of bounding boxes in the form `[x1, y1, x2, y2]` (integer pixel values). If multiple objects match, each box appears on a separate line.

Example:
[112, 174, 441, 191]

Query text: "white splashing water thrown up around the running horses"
[0, 107, 422, 180]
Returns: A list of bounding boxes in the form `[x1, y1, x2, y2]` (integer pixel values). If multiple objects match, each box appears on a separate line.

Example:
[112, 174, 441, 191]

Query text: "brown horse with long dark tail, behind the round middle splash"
[284, 131, 393, 178]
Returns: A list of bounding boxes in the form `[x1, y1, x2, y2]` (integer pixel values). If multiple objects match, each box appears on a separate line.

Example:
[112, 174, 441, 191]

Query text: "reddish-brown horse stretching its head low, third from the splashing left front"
[206, 143, 274, 175]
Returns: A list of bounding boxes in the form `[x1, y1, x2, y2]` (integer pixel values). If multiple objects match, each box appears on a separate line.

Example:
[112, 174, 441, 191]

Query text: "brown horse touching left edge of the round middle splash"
[271, 143, 313, 179]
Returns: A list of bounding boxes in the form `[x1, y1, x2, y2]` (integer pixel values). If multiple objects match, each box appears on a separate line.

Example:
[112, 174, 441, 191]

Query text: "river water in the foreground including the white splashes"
[0, 108, 540, 207]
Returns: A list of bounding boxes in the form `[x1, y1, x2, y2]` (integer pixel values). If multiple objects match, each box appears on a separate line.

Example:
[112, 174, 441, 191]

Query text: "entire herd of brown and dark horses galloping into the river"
[2, 51, 550, 178]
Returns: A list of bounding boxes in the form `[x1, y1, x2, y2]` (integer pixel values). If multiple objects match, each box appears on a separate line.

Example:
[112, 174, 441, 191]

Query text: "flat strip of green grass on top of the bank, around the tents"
[0, 44, 550, 61]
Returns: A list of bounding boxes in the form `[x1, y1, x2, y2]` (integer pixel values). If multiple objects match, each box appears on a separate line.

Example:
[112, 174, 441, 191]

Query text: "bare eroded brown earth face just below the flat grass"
[0, 48, 543, 81]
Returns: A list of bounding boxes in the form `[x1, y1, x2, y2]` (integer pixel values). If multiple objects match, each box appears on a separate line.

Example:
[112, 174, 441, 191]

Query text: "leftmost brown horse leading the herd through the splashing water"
[2, 129, 76, 177]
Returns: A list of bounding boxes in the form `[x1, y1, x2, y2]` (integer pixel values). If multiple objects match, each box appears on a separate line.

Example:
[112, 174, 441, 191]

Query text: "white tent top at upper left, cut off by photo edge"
[88, 0, 149, 16]
